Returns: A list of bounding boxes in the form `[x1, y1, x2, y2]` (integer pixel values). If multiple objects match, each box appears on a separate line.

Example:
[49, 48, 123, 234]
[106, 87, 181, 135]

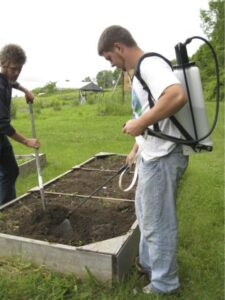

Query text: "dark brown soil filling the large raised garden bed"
[0, 155, 136, 246]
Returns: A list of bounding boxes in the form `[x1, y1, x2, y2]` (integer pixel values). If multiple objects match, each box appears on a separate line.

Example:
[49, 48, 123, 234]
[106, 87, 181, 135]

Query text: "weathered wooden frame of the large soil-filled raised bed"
[0, 153, 139, 284]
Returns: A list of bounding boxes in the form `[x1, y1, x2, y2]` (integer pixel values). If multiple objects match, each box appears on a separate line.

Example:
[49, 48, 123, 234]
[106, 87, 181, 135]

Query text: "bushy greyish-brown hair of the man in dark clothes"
[0, 44, 27, 66]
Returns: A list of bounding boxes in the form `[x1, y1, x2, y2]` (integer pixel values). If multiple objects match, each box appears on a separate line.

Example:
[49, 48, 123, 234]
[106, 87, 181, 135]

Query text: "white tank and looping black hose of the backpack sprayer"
[171, 36, 220, 154]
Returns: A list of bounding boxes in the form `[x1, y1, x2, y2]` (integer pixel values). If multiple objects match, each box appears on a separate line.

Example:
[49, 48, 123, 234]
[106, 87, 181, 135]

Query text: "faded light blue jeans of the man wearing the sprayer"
[135, 146, 188, 293]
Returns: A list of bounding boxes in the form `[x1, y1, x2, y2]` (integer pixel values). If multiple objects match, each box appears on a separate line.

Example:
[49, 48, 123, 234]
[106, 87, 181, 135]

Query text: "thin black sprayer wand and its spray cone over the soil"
[56, 164, 129, 238]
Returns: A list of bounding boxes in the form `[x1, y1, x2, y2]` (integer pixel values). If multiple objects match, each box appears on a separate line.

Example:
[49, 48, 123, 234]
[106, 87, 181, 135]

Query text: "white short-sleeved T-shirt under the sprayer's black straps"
[132, 56, 181, 161]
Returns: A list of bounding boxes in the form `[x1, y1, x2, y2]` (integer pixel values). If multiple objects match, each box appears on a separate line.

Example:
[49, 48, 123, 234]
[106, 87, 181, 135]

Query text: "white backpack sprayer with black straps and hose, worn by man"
[119, 36, 220, 191]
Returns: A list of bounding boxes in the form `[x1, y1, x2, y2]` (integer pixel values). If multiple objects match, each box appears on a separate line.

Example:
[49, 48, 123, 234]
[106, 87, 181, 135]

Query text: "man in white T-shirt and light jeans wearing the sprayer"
[98, 26, 188, 294]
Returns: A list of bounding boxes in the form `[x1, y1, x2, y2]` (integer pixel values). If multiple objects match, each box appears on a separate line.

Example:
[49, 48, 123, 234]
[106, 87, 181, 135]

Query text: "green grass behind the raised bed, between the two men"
[13, 100, 133, 195]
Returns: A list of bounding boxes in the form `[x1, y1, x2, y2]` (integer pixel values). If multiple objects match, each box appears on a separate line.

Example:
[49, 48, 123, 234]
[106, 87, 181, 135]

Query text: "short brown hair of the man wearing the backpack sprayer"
[98, 25, 137, 55]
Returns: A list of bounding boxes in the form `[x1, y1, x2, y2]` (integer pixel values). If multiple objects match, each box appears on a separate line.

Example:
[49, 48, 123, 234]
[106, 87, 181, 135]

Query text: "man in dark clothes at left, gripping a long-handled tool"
[0, 44, 40, 205]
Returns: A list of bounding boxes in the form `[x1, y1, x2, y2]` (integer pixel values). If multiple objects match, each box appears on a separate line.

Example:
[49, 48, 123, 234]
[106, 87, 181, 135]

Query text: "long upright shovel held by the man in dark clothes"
[29, 102, 46, 211]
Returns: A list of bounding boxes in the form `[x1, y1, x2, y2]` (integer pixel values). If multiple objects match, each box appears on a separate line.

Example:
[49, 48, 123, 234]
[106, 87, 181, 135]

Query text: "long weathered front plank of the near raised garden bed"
[0, 234, 113, 284]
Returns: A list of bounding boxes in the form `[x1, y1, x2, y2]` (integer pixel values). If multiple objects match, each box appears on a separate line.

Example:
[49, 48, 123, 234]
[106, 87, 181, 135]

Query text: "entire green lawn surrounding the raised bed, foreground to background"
[0, 94, 224, 300]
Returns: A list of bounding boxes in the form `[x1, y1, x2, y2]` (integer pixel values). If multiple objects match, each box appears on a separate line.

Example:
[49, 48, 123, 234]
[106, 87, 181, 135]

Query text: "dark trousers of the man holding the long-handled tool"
[0, 134, 19, 205]
